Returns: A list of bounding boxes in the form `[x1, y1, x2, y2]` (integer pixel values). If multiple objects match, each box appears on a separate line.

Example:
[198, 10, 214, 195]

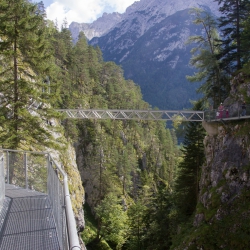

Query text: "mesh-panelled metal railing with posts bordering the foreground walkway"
[2, 149, 81, 250]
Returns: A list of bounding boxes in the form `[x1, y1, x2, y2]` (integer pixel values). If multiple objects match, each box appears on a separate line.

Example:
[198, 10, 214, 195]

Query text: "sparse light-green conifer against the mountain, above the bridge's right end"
[187, 8, 229, 107]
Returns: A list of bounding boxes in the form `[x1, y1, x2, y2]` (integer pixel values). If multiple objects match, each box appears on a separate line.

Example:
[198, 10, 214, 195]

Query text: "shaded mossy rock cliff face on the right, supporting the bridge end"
[186, 75, 250, 249]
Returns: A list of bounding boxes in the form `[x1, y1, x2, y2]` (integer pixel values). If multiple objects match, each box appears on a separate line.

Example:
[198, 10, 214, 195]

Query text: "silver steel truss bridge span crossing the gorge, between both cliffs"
[57, 109, 204, 121]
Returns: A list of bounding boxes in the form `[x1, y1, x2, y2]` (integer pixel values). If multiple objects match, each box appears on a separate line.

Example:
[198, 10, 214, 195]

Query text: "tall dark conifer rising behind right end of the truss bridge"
[175, 102, 205, 218]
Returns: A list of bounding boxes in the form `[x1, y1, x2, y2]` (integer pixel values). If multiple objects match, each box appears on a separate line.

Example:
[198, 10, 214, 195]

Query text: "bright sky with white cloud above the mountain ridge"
[33, 0, 140, 27]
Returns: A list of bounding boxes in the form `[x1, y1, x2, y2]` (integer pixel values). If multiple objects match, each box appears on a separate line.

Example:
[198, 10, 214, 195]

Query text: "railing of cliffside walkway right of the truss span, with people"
[204, 103, 250, 121]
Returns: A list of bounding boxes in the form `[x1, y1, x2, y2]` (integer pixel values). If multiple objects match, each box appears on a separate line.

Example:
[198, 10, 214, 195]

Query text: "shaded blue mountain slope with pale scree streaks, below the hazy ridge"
[91, 9, 207, 109]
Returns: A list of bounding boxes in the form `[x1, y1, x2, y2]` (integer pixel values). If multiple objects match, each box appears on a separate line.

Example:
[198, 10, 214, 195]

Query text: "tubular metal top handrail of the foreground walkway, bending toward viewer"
[0, 149, 81, 250]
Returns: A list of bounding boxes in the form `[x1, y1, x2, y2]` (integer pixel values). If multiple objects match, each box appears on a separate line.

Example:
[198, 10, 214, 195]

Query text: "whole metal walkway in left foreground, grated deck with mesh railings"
[0, 149, 81, 250]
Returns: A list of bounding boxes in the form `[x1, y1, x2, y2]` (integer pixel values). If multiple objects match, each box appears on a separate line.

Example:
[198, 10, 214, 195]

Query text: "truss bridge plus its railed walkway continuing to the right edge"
[57, 105, 250, 122]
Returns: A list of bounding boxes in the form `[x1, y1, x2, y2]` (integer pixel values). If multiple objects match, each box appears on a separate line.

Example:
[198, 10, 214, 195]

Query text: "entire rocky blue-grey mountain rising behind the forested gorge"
[70, 0, 218, 109]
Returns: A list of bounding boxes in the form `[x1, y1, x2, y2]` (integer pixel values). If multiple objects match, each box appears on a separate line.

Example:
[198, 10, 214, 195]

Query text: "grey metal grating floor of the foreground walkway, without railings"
[0, 185, 60, 250]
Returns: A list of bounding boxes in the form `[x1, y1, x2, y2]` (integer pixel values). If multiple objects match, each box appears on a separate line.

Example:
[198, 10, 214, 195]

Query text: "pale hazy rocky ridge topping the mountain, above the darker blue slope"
[69, 0, 219, 41]
